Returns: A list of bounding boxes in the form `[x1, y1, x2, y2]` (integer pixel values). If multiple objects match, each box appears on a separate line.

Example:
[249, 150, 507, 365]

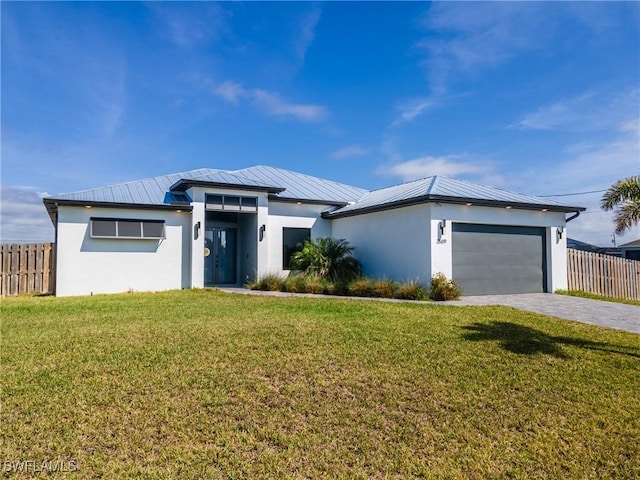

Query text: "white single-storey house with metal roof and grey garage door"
[43, 166, 584, 296]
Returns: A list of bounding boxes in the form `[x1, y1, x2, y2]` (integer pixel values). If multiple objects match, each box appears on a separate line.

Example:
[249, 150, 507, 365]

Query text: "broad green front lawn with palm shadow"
[0, 290, 640, 479]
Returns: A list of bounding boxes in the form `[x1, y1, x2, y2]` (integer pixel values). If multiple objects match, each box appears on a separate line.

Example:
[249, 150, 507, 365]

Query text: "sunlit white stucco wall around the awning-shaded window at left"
[56, 206, 191, 297]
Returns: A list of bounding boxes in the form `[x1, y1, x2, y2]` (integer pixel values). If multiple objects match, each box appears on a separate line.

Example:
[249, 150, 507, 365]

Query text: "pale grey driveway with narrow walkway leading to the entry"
[220, 288, 640, 334]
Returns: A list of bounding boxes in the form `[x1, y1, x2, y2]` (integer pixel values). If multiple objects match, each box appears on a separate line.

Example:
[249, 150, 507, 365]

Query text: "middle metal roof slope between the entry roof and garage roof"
[231, 165, 368, 205]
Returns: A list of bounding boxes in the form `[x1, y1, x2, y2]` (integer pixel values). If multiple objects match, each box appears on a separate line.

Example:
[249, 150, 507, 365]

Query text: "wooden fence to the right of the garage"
[567, 248, 640, 300]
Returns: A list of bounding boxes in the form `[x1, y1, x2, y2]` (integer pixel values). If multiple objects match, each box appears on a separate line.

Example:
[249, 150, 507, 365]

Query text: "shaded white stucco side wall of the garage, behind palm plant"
[332, 205, 431, 283]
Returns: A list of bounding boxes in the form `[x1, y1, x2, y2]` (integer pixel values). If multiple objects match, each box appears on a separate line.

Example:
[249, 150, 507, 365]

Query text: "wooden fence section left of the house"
[0, 243, 55, 297]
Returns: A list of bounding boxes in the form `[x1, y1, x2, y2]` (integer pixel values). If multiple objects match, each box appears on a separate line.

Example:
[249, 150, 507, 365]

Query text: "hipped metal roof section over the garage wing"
[325, 176, 584, 218]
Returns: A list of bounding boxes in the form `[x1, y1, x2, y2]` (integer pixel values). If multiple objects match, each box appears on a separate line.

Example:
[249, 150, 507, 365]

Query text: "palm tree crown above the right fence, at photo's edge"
[600, 176, 640, 234]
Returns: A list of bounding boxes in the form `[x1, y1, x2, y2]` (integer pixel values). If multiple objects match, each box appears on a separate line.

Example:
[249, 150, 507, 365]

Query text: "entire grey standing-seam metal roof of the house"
[44, 165, 584, 218]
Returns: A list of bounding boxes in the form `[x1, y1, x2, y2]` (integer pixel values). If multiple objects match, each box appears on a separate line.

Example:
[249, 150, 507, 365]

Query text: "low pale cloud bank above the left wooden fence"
[0, 185, 54, 243]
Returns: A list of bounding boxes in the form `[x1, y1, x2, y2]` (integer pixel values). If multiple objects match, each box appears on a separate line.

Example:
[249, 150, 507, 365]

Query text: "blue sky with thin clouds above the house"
[0, 2, 640, 245]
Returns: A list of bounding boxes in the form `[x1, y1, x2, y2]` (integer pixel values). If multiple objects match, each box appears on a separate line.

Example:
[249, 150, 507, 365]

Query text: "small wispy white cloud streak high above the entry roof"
[213, 81, 328, 122]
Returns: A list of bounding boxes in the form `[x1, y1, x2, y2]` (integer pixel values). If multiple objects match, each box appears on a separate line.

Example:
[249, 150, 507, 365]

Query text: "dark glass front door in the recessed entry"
[204, 228, 238, 286]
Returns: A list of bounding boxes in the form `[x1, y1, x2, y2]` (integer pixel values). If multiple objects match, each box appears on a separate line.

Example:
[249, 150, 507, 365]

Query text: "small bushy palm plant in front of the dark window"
[291, 237, 361, 282]
